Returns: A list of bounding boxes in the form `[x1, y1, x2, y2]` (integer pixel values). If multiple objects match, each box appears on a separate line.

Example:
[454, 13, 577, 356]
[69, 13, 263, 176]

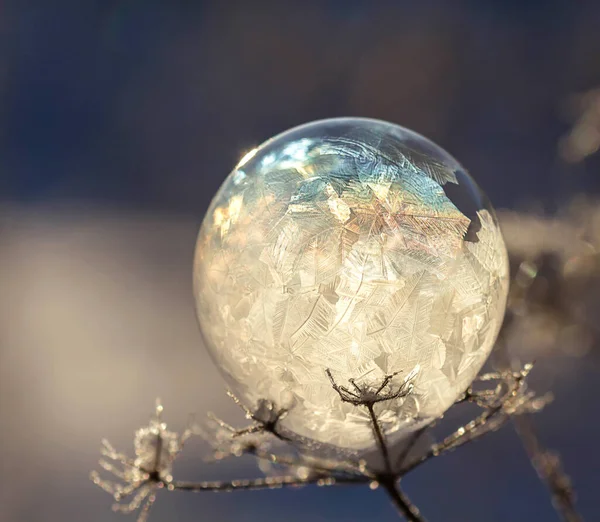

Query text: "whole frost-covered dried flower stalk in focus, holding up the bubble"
[91, 365, 548, 522]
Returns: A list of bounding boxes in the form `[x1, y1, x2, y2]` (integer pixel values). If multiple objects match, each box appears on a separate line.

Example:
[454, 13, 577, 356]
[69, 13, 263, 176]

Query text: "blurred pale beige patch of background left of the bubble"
[0, 205, 241, 522]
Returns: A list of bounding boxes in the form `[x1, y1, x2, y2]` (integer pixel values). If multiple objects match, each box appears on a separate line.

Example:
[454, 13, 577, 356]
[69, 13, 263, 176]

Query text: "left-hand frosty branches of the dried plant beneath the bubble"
[91, 394, 373, 522]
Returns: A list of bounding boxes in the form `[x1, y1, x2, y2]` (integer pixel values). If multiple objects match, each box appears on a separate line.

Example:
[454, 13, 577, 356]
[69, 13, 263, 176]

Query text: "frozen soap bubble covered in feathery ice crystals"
[194, 118, 508, 451]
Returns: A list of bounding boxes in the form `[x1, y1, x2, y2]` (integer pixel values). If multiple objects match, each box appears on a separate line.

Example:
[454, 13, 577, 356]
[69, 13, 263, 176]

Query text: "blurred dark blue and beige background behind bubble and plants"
[0, 0, 600, 522]
